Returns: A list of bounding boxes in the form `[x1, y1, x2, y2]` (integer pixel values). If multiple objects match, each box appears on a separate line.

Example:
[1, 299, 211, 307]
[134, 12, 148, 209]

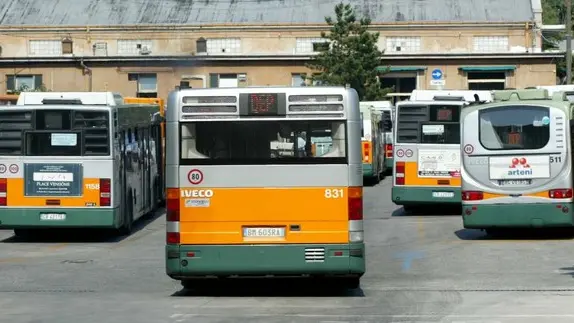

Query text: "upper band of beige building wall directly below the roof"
[0, 24, 535, 57]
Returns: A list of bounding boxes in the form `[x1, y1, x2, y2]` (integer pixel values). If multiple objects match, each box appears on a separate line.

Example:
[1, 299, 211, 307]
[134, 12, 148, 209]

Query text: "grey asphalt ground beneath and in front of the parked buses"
[0, 178, 574, 323]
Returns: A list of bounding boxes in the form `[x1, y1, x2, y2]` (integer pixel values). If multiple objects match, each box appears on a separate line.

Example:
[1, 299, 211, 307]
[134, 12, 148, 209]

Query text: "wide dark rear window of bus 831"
[180, 120, 347, 165]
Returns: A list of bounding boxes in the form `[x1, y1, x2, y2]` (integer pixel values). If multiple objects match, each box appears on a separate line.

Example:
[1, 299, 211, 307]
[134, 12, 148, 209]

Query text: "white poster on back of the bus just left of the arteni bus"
[418, 149, 460, 178]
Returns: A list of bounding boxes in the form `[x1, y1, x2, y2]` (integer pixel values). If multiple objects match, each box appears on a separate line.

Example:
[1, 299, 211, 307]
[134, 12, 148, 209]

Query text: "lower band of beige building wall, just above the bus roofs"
[0, 59, 556, 97]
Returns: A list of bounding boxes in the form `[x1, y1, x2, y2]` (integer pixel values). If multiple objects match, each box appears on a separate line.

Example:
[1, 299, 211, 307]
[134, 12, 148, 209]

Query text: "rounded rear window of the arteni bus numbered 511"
[479, 105, 550, 150]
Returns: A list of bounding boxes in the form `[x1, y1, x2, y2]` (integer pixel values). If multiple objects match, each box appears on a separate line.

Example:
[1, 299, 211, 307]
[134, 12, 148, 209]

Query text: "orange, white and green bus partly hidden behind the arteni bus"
[392, 91, 491, 211]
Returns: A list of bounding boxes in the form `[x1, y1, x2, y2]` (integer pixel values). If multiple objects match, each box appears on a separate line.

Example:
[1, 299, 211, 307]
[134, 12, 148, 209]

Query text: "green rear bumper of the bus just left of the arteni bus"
[391, 186, 462, 205]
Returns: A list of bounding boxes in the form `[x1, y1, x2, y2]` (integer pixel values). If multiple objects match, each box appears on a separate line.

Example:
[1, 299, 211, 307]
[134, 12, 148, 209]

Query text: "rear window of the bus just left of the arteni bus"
[396, 104, 461, 144]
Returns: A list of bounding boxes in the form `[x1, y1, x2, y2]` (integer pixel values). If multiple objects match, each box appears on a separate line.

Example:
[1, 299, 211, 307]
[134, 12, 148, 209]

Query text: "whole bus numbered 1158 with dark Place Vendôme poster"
[0, 92, 162, 235]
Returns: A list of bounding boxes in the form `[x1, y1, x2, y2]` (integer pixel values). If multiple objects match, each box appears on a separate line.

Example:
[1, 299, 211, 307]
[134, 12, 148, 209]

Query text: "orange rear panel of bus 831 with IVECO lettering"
[180, 187, 352, 244]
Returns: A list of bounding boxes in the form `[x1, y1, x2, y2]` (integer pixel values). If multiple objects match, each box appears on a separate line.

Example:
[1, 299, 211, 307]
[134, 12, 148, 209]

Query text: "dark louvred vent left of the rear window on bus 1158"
[0, 110, 32, 155]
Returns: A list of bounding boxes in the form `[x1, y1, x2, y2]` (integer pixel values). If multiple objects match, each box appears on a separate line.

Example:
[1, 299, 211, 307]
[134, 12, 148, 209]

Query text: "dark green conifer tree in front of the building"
[304, 2, 391, 101]
